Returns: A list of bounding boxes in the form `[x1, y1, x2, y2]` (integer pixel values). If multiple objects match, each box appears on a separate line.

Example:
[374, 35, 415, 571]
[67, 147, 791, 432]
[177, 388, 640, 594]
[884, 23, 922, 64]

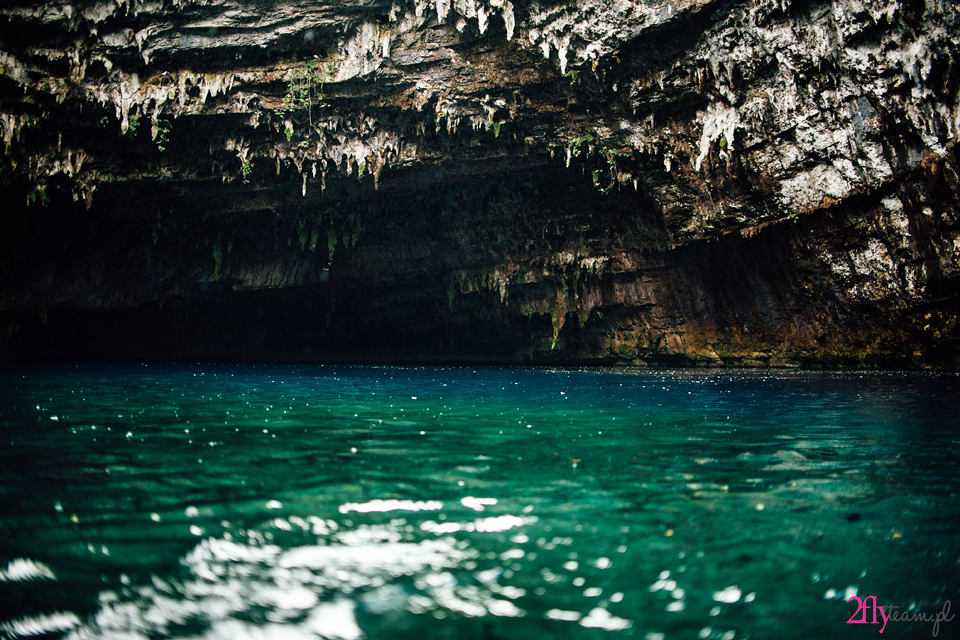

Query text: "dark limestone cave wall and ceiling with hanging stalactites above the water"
[0, 0, 960, 368]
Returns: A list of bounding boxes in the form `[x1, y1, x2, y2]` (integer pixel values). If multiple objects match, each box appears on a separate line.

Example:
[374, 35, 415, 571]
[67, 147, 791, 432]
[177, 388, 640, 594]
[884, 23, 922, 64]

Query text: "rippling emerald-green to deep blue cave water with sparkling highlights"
[0, 365, 960, 640]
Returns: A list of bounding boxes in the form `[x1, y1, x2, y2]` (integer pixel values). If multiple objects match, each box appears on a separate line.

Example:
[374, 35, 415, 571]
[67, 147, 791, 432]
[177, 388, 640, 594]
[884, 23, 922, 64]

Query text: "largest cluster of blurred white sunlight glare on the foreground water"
[58, 501, 540, 640]
